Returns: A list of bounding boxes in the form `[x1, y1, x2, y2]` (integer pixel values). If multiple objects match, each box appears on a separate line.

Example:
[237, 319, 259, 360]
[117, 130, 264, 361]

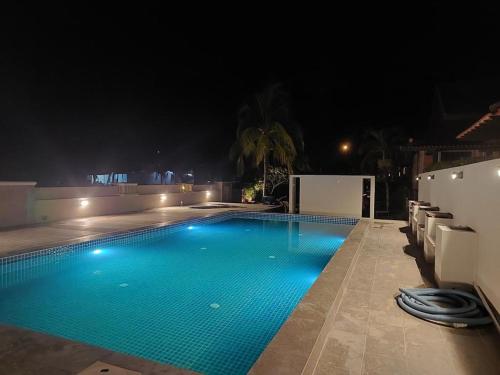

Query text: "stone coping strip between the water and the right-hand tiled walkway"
[249, 219, 370, 375]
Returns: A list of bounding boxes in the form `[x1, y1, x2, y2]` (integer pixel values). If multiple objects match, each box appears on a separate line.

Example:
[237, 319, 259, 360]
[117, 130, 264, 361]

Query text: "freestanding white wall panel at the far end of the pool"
[290, 175, 375, 219]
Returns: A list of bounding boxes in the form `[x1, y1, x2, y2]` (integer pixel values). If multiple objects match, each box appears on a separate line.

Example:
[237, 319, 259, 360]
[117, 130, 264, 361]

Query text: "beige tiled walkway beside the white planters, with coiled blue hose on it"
[314, 221, 500, 375]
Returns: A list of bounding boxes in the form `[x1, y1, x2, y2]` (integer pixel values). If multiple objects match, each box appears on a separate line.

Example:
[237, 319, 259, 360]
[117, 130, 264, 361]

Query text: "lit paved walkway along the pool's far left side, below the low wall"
[0, 202, 270, 257]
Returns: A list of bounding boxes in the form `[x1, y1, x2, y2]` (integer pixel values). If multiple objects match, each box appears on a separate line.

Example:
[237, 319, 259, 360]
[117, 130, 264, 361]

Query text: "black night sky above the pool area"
[0, 2, 500, 183]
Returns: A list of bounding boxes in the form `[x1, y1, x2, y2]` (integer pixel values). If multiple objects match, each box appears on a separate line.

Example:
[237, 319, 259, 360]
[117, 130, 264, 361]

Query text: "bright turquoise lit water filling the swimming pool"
[0, 218, 353, 374]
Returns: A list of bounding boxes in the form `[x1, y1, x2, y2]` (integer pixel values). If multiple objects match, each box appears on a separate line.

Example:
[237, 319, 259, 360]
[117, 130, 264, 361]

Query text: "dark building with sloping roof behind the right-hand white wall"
[401, 81, 500, 197]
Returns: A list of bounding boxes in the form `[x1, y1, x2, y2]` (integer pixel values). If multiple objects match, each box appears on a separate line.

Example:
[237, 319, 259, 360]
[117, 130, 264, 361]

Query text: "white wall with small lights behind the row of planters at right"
[418, 159, 500, 311]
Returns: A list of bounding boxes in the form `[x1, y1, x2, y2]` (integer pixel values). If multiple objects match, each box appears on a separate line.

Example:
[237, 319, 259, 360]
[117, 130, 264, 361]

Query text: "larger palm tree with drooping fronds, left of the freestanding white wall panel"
[230, 84, 296, 195]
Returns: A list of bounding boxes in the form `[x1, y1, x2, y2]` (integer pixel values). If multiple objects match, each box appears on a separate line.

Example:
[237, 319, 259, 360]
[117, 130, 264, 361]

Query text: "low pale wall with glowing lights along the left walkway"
[0, 181, 220, 228]
